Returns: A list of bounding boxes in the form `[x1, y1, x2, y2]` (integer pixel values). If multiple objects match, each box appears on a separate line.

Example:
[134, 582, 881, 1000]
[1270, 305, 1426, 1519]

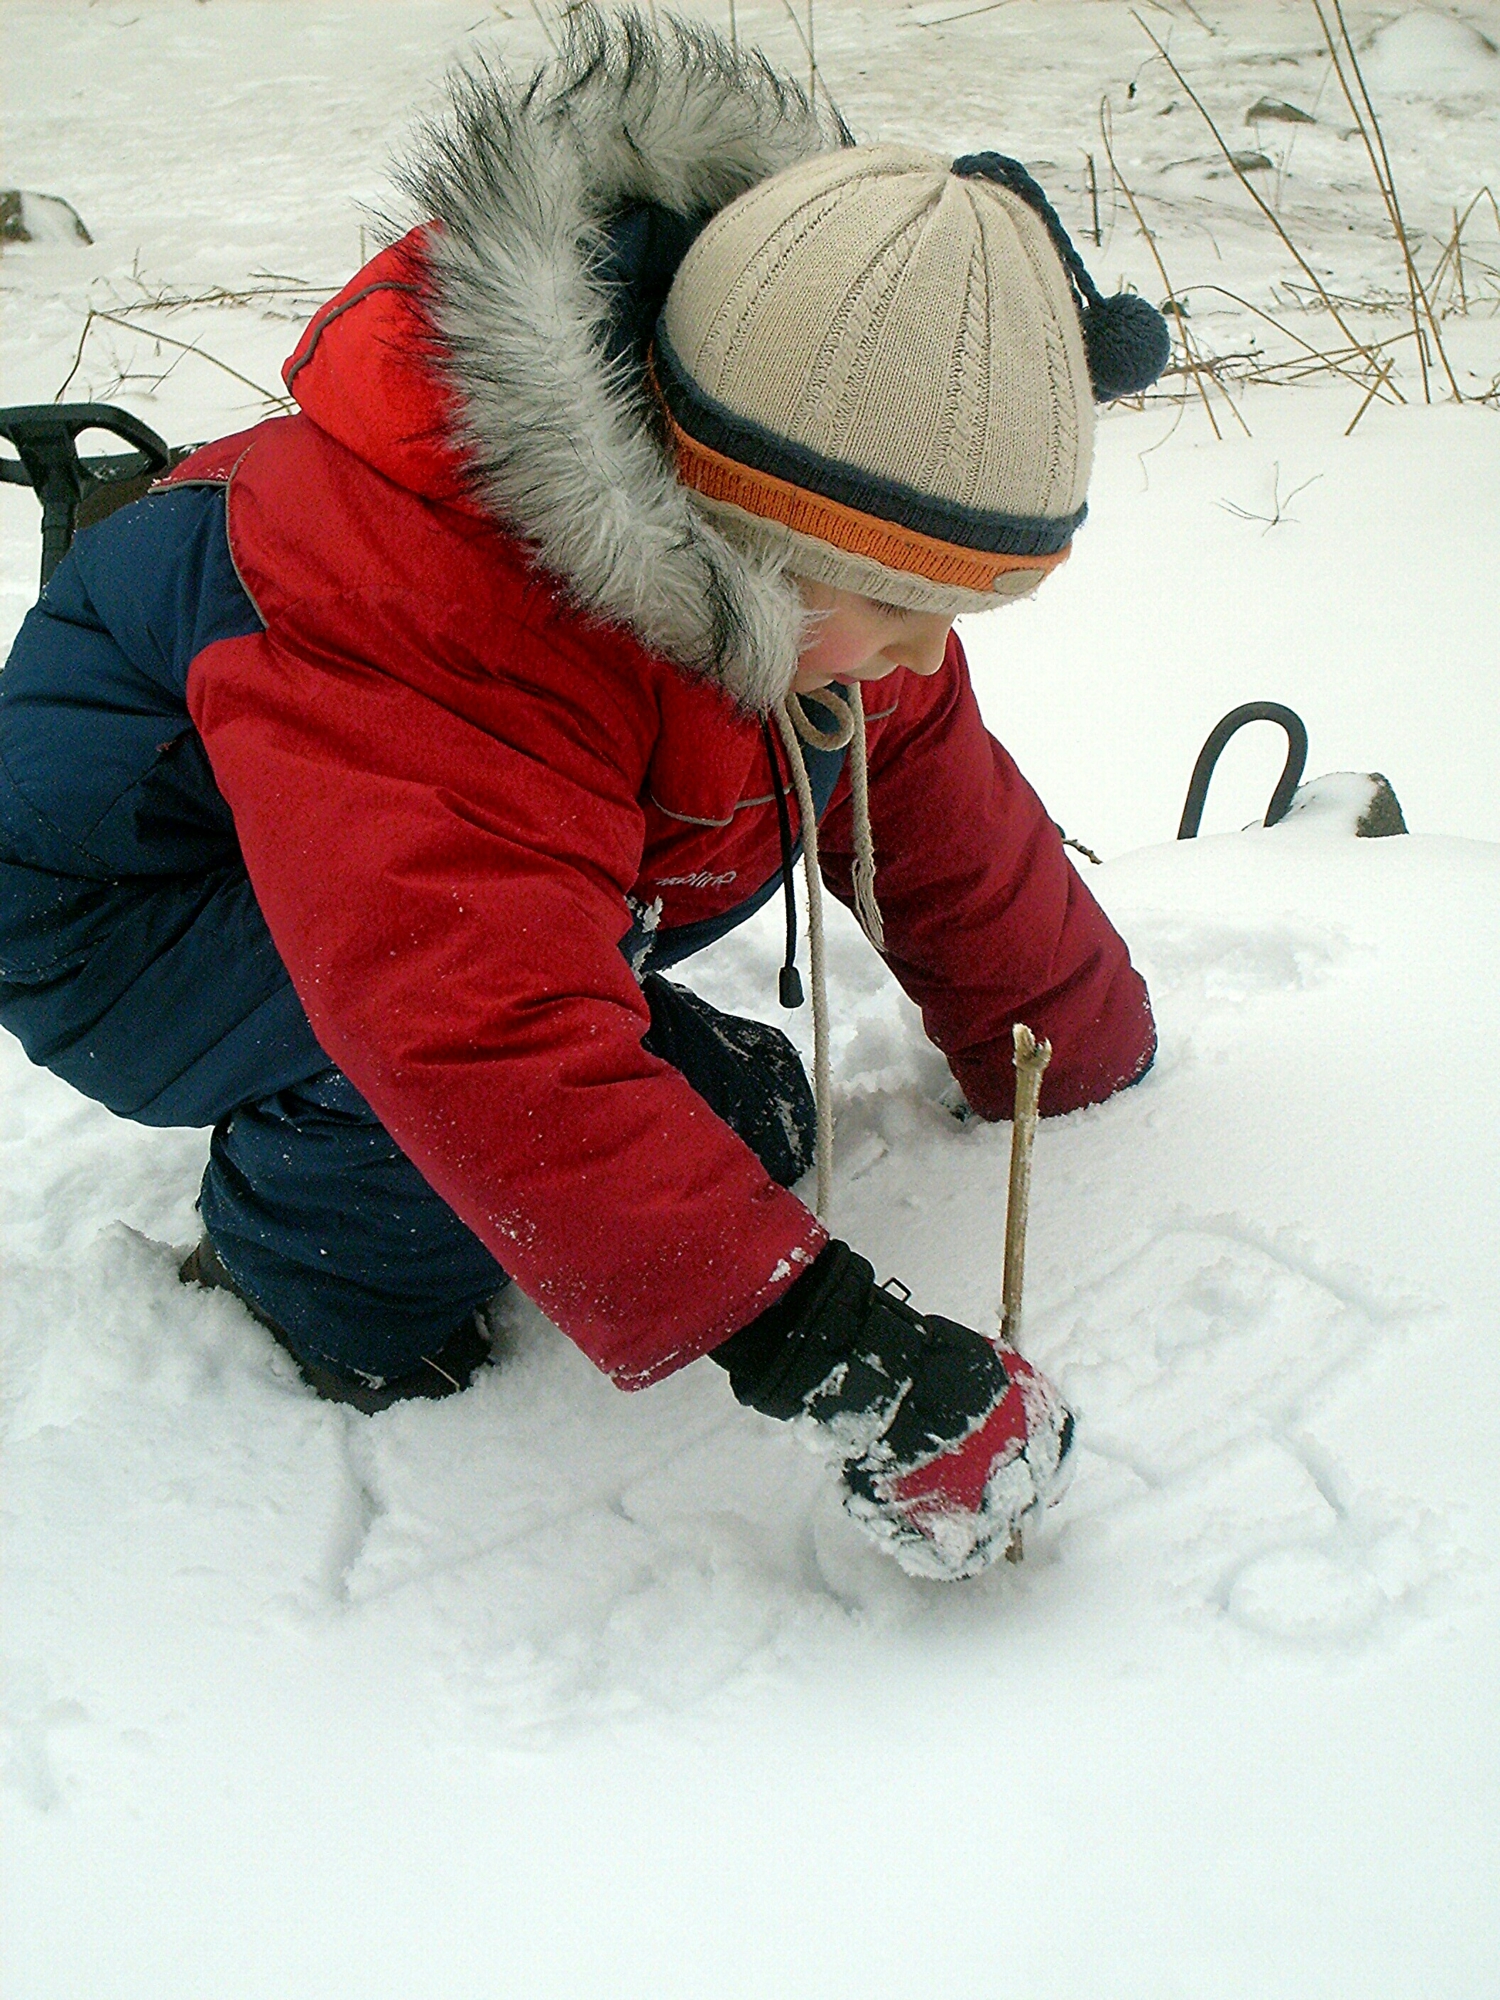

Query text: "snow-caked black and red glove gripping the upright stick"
[714, 1242, 1072, 1580]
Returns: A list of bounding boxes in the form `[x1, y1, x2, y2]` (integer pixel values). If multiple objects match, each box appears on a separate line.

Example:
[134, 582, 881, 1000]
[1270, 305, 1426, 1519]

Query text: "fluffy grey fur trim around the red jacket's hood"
[400, 4, 850, 712]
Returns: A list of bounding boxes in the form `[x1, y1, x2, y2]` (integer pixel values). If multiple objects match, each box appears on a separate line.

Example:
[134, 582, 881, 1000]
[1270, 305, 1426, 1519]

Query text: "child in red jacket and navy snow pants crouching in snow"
[0, 8, 1166, 1576]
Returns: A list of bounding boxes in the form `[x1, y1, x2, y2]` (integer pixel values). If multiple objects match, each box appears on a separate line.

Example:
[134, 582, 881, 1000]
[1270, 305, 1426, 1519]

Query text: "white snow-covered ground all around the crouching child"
[0, 0, 1500, 2000]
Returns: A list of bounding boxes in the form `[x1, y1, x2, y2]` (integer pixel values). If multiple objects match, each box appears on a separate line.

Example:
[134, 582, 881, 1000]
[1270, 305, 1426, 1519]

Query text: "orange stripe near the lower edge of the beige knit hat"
[658, 406, 1068, 592]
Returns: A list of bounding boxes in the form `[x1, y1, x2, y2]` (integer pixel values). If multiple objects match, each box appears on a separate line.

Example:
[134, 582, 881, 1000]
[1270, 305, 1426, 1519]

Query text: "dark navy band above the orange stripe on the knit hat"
[656, 320, 1088, 556]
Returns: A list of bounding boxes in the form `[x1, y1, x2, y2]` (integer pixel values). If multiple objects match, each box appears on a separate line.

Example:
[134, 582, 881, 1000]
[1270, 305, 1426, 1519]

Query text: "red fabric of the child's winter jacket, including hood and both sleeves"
[178, 78, 1154, 1388]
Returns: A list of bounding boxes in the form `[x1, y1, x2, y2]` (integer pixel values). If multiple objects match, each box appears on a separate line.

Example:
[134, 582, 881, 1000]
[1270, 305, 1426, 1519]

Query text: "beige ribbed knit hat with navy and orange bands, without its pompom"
[652, 146, 1094, 614]
